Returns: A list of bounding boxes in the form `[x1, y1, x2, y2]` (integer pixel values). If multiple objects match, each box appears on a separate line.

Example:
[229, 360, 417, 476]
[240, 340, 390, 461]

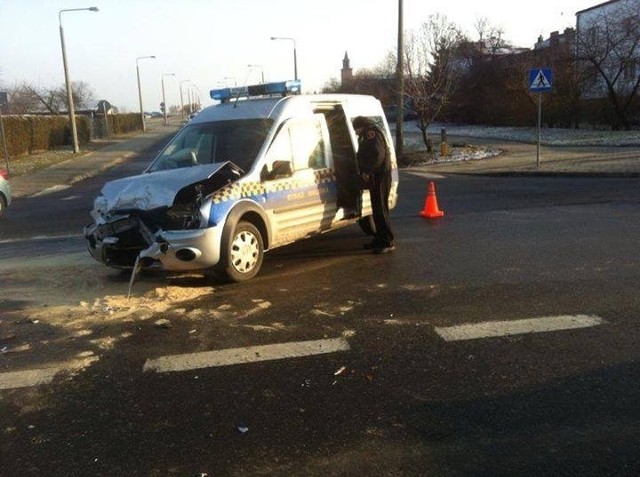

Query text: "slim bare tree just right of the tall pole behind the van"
[405, 14, 466, 152]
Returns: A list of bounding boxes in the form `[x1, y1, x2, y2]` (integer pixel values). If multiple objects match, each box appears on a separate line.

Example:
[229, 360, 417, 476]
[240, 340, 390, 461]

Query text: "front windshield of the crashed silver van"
[147, 118, 273, 172]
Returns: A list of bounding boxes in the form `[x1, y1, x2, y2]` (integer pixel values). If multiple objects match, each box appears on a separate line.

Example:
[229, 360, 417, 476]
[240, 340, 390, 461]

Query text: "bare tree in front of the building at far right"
[576, 0, 640, 129]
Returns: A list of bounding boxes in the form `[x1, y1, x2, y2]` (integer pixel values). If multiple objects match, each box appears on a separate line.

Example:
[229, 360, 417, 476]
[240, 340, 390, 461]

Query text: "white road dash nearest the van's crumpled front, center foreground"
[142, 338, 350, 373]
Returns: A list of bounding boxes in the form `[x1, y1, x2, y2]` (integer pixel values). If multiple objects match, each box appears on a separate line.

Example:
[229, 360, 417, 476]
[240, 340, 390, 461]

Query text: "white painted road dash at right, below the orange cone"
[436, 315, 604, 341]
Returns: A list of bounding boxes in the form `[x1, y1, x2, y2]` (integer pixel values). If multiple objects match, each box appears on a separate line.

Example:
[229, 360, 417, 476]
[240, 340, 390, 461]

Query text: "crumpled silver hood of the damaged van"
[101, 163, 226, 211]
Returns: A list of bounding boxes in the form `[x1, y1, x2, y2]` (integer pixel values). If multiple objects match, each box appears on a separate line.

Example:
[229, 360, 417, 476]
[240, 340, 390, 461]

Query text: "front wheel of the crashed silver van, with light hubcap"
[216, 221, 264, 282]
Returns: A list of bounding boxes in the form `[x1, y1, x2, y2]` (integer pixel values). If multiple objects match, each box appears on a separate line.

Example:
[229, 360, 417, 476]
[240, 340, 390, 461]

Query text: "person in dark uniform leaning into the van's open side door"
[353, 116, 395, 253]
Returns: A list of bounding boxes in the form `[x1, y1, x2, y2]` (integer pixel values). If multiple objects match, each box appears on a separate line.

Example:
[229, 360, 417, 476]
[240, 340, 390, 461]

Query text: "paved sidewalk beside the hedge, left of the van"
[10, 123, 179, 200]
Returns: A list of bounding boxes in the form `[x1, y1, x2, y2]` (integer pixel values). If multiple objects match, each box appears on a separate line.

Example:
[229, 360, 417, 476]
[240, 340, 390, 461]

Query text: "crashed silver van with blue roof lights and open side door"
[84, 81, 398, 282]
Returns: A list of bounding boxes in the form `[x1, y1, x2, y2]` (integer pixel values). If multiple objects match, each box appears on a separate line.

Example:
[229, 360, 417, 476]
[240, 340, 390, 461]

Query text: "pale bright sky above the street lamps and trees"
[0, 0, 602, 112]
